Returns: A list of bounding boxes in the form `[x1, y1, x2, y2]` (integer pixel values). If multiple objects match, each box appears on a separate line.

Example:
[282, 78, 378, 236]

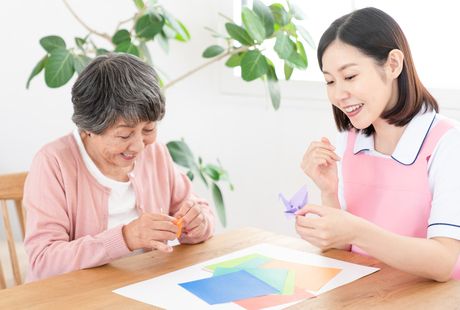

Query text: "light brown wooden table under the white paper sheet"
[0, 228, 460, 310]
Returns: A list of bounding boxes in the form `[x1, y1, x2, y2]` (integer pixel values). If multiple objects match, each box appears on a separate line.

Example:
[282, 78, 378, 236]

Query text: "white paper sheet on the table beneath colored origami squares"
[113, 243, 379, 309]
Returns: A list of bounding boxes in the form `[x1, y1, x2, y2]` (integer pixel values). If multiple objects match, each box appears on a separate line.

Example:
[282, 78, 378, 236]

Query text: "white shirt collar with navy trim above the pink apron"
[353, 111, 436, 165]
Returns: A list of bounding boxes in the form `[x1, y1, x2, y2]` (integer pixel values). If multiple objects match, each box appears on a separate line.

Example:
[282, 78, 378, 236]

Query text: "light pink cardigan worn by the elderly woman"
[24, 134, 214, 281]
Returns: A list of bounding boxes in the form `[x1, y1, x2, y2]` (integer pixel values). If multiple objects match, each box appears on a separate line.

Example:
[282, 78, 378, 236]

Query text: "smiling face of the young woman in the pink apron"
[322, 40, 399, 129]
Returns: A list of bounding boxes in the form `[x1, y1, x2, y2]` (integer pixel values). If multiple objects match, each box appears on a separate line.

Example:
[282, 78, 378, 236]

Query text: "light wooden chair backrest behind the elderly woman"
[0, 172, 27, 289]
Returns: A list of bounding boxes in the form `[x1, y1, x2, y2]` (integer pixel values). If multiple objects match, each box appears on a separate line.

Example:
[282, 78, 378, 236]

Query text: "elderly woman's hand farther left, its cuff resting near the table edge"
[122, 213, 178, 252]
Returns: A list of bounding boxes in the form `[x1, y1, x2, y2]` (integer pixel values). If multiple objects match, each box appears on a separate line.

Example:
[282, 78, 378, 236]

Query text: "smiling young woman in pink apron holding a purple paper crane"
[296, 8, 460, 281]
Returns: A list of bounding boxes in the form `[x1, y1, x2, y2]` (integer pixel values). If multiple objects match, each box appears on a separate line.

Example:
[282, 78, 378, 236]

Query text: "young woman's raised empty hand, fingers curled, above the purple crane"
[300, 137, 340, 195]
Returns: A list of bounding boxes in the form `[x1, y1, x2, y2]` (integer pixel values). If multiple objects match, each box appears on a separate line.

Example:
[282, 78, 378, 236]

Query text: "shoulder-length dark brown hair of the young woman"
[317, 7, 439, 135]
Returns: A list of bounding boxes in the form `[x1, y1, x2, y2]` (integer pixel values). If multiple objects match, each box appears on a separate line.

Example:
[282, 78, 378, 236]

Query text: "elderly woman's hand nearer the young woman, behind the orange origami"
[174, 200, 208, 243]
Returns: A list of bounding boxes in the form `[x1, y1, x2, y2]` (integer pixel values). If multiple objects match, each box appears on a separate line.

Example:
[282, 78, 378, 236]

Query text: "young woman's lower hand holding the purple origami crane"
[295, 205, 359, 250]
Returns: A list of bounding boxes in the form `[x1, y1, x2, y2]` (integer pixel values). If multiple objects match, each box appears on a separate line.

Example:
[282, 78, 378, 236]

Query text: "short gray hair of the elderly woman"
[72, 53, 165, 134]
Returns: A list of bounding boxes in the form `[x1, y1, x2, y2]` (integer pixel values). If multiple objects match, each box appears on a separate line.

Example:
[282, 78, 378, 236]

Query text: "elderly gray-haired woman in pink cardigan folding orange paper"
[24, 54, 214, 281]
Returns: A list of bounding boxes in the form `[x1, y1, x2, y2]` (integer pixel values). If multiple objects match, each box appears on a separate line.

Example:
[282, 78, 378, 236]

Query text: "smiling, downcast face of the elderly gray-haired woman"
[82, 120, 157, 180]
